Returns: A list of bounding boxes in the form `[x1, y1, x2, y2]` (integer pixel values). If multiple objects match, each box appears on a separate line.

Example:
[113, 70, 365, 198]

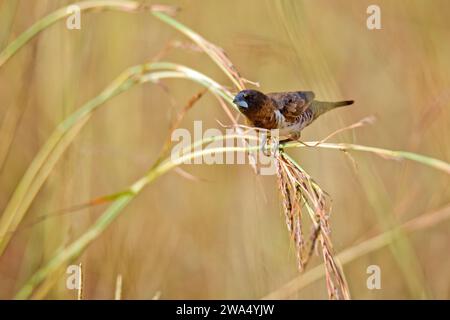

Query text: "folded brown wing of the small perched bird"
[267, 91, 315, 122]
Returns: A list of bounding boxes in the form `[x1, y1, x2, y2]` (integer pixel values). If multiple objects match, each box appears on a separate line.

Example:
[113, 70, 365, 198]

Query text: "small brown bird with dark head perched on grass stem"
[233, 90, 354, 141]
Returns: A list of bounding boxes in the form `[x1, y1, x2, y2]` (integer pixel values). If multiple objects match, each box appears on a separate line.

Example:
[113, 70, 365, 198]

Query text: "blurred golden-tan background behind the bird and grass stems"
[0, 0, 450, 299]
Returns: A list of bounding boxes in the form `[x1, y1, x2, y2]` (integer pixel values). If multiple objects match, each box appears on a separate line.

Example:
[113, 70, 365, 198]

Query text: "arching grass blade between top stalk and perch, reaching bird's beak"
[0, 62, 237, 255]
